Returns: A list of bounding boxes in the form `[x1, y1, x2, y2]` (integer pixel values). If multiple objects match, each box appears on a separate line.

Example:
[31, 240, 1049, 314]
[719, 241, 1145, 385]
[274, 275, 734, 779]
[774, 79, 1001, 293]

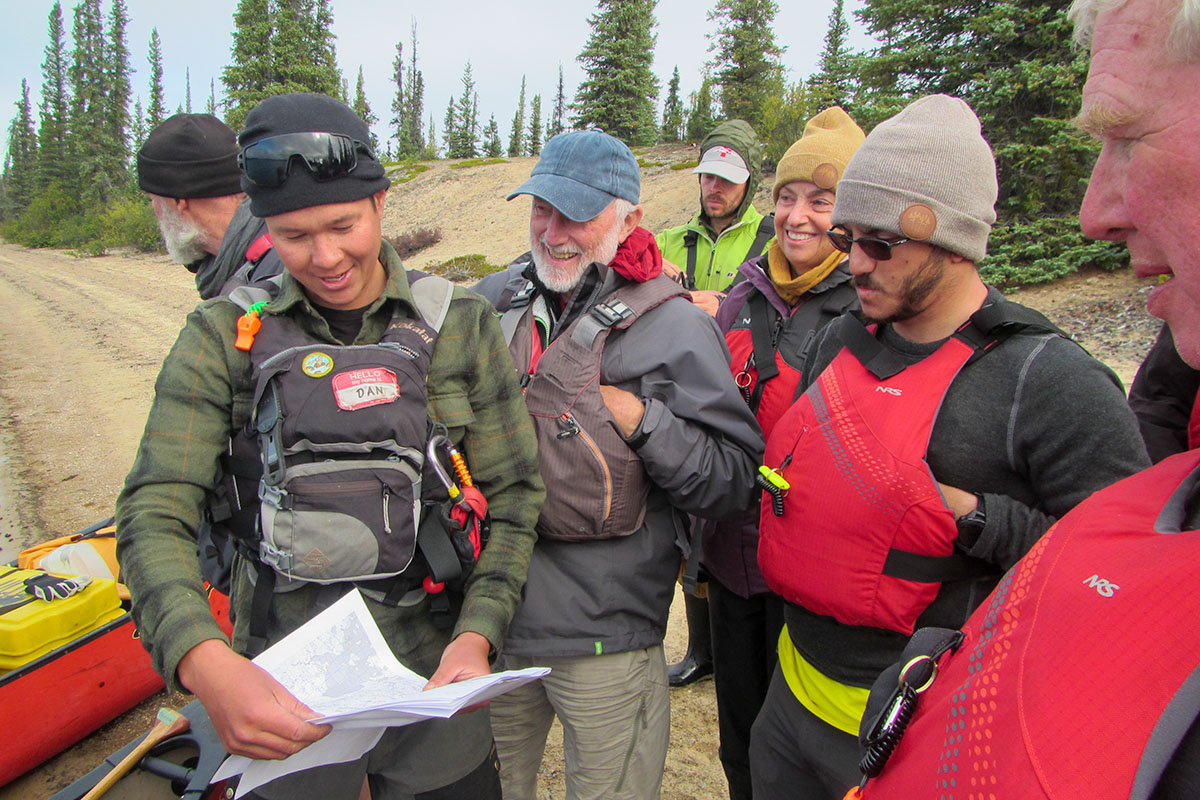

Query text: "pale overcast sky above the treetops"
[0, 0, 871, 144]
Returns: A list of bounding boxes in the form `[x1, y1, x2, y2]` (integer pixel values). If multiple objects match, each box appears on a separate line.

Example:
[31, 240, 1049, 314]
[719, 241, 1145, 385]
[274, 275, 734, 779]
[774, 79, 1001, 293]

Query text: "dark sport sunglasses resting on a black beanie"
[238, 132, 374, 187]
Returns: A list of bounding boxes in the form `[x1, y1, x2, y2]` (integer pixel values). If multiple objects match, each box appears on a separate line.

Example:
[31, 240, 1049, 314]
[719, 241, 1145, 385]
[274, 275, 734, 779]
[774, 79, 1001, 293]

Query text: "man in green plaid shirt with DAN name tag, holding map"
[116, 95, 544, 800]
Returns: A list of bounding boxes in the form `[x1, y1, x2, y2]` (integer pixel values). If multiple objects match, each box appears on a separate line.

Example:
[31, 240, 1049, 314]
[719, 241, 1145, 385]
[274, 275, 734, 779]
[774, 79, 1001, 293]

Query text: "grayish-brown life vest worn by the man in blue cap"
[500, 275, 689, 541]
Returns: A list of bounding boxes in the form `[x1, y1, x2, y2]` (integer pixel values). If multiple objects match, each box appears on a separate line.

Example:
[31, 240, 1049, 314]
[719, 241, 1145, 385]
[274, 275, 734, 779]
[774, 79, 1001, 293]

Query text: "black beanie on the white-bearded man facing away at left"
[138, 114, 241, 198]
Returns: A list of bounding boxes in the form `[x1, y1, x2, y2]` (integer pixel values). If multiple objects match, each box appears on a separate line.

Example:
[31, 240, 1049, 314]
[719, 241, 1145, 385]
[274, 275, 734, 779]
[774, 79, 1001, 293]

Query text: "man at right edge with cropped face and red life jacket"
[840, 0, 1200, 800]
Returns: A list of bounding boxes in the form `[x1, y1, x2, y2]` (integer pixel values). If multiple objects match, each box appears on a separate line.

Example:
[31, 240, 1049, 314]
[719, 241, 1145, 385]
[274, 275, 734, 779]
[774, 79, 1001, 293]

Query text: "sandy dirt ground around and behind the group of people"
[0, 148, 1158, 800]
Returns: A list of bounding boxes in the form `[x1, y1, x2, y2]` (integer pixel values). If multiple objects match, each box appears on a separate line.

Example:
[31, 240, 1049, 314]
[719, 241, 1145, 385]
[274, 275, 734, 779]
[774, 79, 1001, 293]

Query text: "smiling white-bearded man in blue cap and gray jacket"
[476, 131, 762, 800]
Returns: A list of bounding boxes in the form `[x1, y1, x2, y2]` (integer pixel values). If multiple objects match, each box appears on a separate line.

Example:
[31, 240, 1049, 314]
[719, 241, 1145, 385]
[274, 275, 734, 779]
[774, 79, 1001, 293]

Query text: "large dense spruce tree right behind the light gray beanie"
[856, 0, 1126, 283]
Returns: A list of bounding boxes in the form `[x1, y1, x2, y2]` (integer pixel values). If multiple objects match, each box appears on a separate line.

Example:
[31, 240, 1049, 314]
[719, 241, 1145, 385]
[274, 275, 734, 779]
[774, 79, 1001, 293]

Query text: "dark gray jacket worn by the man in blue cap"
[475, 257, 763, 656]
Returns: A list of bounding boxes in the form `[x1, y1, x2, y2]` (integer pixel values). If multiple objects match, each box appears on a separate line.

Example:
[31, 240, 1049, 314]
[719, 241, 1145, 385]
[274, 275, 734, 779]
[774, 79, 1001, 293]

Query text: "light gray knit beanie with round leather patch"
[832, 95, 998, 261]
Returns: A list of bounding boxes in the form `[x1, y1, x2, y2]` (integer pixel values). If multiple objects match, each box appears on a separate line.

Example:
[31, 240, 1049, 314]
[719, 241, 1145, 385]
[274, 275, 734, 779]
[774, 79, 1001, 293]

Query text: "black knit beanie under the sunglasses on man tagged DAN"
[238, 94, 391, 217]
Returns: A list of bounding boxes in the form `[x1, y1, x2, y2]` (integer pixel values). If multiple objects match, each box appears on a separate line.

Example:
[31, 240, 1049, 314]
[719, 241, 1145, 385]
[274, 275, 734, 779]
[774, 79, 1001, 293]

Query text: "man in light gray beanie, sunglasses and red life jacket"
[750, 95, 1148, 800]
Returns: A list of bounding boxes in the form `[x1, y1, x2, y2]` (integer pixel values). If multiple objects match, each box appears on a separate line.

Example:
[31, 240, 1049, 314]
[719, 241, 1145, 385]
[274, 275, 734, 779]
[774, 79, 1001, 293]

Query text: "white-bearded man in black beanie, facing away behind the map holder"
[138, 114, 271, 300]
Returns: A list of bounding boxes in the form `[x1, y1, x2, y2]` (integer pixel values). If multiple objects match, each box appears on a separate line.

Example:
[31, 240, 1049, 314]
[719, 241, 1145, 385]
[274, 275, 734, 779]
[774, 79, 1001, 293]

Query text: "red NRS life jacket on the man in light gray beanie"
[758, 301, 1057, 633]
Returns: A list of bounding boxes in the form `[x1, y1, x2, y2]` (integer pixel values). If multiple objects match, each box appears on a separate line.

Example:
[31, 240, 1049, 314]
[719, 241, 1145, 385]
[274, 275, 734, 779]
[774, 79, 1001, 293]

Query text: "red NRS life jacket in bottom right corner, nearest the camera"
[863, 453, 1200, 800]
